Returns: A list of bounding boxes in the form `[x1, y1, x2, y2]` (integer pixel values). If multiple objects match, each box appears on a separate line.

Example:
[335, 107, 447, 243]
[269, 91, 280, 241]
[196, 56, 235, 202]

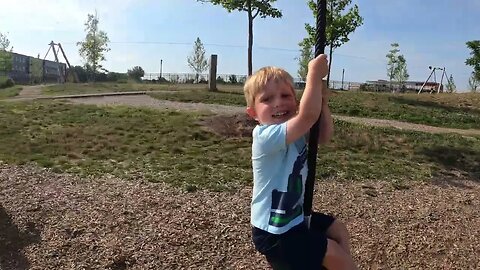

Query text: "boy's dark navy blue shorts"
[252, 213, 335, 270]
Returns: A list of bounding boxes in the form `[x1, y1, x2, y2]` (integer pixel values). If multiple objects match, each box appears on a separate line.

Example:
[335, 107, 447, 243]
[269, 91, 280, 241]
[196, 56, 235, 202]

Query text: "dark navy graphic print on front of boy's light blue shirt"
[268, 146, 307, 227]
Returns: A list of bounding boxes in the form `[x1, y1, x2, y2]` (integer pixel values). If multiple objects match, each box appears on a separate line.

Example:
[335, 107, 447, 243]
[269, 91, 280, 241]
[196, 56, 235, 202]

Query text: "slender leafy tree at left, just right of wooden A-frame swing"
[77, 14, 110, 81]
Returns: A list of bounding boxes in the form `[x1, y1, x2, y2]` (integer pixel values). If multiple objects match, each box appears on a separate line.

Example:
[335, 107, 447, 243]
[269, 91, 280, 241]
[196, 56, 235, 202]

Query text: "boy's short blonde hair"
[243, 67, 293, 107]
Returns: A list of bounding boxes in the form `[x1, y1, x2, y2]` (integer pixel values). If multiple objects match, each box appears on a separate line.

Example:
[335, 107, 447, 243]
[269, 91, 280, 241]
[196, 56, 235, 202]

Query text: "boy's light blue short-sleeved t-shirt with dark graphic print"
[250, 123, 307, 234]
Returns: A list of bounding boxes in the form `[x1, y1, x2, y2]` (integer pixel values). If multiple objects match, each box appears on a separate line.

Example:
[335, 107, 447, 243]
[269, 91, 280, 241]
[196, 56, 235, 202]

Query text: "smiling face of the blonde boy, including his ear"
[247, 80, 297, 125]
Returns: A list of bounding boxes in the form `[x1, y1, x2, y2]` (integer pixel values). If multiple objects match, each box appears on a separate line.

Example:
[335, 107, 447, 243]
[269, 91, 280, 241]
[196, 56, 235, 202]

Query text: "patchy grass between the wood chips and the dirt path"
[0, 101, 480, 190]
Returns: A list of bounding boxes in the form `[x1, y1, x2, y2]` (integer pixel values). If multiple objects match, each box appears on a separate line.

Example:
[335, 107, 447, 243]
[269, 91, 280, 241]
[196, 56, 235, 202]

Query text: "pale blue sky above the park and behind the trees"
[0, 0, 480, 91]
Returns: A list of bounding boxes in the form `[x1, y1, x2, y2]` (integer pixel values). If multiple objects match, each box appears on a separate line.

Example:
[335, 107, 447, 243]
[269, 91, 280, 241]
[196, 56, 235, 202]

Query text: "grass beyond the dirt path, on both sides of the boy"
[40, 83, 480, 129]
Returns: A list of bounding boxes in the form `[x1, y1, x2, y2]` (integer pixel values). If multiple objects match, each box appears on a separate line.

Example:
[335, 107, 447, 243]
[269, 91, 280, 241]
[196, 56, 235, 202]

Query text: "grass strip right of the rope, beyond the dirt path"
[330, 92, 480, 129]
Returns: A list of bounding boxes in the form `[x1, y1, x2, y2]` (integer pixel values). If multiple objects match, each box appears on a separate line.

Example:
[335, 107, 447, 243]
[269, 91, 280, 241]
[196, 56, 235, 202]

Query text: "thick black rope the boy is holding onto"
[303, 0, 327, 216]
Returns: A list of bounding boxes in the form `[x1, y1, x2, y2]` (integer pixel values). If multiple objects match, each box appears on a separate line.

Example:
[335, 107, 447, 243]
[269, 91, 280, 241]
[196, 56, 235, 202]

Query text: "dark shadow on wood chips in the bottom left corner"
[0, 204, 40, 270]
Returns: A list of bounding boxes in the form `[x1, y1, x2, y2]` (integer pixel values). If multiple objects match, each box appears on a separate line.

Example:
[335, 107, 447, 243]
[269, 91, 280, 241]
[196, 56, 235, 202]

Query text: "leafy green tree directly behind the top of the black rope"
[304, 0, 363, 83]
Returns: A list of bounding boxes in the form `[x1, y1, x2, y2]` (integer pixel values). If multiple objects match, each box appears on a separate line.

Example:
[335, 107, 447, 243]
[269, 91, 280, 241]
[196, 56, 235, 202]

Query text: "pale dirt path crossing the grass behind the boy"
[68, 95, 480, 136]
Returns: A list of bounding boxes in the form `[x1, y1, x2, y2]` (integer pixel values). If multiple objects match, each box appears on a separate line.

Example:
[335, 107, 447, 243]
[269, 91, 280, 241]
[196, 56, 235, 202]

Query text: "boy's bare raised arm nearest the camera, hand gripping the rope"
[286, 54, 328, 144]
